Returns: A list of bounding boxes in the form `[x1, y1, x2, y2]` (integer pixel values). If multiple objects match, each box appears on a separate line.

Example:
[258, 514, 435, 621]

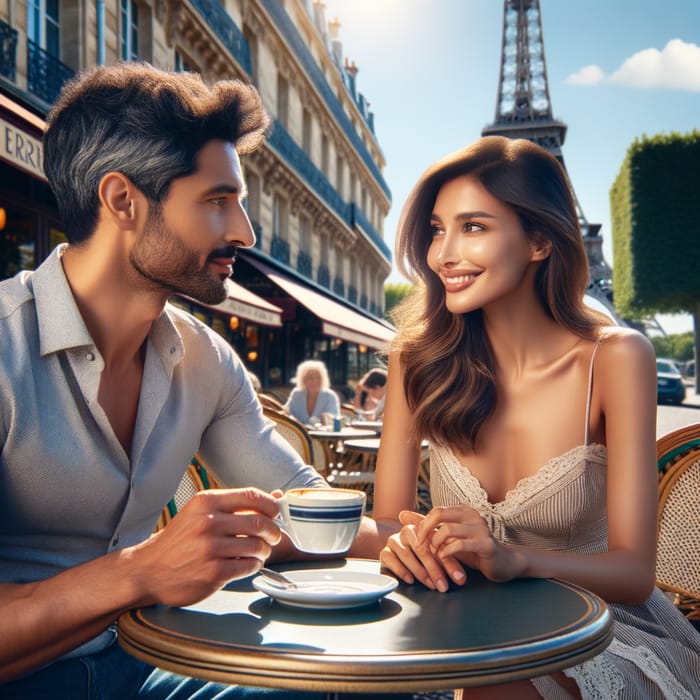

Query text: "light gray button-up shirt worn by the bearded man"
[0, 247, 323, 656]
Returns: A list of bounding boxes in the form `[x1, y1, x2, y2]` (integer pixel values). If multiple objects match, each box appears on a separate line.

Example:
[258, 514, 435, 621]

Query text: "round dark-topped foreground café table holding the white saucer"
[119, 559, 613, 697]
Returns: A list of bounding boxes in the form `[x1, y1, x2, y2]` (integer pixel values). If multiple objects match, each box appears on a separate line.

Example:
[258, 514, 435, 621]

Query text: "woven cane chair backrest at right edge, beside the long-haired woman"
[656, 450, 700, 598]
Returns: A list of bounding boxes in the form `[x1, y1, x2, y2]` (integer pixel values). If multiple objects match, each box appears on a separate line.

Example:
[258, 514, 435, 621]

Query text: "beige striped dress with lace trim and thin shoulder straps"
[430, 348, 700, 700]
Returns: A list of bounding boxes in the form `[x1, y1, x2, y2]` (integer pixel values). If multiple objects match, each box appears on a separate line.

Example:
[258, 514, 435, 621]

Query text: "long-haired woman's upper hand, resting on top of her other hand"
[414, 506, 526, 582]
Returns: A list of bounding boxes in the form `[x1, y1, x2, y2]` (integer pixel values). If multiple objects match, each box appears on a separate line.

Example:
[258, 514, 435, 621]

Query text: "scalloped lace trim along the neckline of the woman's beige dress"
[431, 443, 607, 517]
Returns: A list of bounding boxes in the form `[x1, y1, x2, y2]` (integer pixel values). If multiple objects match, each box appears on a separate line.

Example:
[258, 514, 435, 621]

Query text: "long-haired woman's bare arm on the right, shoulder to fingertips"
[417, 329, 657, 605]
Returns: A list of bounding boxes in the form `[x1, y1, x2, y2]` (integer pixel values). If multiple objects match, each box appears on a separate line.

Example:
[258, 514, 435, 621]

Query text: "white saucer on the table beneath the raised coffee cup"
[253, 569, 399, 609]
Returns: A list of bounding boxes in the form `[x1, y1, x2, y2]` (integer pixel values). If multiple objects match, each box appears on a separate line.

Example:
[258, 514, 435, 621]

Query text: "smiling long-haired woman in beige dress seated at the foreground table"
[374, 137, 700, 700]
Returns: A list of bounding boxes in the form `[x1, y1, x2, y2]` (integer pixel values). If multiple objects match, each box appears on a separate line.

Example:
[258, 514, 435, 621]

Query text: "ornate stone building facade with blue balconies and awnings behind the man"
[0, 0, 393, 396]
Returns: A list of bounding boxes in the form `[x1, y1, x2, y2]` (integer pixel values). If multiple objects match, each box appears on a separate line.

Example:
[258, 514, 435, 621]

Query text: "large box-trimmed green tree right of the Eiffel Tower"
[610, 130, 700, 391]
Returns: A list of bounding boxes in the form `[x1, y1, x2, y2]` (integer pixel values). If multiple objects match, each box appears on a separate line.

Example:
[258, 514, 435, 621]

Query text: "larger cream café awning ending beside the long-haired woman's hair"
[245, 255, 396, 348]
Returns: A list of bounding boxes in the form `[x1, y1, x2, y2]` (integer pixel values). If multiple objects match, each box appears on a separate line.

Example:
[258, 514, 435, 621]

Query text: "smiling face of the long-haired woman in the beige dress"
[427, 175, 546, 313]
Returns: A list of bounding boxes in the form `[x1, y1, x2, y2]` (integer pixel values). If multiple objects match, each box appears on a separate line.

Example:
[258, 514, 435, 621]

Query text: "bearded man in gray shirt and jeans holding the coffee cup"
[0, 64, 378, 698]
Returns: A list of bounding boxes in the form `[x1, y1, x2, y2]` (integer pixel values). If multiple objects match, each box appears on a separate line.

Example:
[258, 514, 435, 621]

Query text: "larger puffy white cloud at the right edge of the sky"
[608, 39, 700, 92]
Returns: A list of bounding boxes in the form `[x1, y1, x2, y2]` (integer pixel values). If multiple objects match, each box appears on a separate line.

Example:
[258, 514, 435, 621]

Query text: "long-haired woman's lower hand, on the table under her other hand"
[379, 510, 466, 593]
